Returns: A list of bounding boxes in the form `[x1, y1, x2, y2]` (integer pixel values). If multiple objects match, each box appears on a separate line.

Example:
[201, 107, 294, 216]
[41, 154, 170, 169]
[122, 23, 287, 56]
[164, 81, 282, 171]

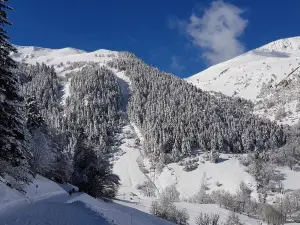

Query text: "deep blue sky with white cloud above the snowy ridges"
[9, 0, 300, 77]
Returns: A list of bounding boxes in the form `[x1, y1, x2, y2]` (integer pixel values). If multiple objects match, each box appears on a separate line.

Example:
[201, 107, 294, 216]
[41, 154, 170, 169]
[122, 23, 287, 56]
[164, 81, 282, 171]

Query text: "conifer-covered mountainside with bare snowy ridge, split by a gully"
[13, 44, 286, 163]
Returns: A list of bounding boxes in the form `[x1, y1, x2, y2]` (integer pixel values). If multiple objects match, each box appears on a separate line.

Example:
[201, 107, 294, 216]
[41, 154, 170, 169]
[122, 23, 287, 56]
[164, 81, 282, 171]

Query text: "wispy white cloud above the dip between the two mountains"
[185, 0, 248, 64]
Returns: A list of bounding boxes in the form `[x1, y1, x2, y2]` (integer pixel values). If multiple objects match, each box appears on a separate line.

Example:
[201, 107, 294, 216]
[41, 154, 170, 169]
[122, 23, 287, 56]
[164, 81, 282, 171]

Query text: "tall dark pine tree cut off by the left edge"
[0, 0, 27, 166]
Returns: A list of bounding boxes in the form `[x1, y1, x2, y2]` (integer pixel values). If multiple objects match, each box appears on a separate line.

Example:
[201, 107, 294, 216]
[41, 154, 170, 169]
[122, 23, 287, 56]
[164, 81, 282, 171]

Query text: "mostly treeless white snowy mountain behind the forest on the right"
[186, 37, 300, 124]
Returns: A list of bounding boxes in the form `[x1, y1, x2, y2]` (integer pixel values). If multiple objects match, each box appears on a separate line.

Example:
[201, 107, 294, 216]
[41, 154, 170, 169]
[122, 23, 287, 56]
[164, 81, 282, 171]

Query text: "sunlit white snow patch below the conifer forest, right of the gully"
[151, 154, 256, 198]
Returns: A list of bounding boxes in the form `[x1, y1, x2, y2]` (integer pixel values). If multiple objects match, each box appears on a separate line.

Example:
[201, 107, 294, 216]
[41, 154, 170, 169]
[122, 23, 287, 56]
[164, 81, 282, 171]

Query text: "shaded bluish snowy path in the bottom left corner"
[0, 194, 110, 225]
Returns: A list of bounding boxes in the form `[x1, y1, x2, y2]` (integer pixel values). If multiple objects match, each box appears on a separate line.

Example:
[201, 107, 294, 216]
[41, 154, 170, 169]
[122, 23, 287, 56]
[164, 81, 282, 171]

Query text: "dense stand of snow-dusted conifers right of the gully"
[109, 53, 286, 162]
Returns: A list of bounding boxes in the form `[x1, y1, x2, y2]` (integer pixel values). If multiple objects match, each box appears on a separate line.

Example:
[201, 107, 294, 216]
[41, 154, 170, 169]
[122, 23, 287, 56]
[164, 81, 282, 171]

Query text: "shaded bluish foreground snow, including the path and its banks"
[0, 176, 171, 225]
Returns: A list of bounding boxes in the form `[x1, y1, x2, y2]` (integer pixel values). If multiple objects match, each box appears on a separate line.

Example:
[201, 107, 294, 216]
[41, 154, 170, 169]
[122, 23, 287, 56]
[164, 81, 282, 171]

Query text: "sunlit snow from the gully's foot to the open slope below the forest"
[114, 125, 258, 199]
